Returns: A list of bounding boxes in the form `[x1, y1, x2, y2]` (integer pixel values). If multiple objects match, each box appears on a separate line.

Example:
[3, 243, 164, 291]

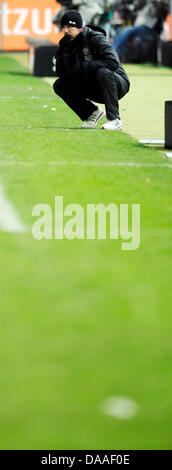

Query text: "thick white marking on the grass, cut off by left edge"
[0, 184, 26, 233]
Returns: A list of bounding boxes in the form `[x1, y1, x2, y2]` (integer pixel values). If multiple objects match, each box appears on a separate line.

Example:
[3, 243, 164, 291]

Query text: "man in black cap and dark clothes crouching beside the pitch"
[53, 10, 130, 130]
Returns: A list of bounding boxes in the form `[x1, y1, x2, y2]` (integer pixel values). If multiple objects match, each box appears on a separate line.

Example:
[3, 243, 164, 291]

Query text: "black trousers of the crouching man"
[53, 68, 129, 121]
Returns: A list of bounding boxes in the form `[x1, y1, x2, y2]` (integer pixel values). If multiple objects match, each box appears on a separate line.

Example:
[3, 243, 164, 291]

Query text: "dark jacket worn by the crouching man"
[56, 25, 130, 88]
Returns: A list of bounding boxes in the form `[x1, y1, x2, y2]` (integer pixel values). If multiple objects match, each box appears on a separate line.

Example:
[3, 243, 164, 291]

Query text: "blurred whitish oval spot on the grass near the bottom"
[101, 397, 139, 420]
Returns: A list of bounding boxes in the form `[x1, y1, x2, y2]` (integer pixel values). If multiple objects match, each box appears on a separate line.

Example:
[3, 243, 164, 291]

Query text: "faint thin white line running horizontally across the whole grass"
[0, 160, 172, 169]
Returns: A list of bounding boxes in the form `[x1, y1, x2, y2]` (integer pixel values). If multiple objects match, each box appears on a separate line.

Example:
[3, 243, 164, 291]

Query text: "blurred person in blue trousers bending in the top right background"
[113, 0, 169, 59]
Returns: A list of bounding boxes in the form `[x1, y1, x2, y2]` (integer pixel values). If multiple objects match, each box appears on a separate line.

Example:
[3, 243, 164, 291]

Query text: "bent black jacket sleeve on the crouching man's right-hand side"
[83, 35, 120, 72]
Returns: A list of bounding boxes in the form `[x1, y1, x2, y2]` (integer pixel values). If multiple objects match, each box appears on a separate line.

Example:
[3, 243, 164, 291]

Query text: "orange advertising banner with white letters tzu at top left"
[0, 0, 60, 51]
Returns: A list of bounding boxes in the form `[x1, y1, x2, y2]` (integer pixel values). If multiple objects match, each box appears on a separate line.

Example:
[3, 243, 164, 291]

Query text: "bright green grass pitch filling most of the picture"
[0, 55, 172, 449]
